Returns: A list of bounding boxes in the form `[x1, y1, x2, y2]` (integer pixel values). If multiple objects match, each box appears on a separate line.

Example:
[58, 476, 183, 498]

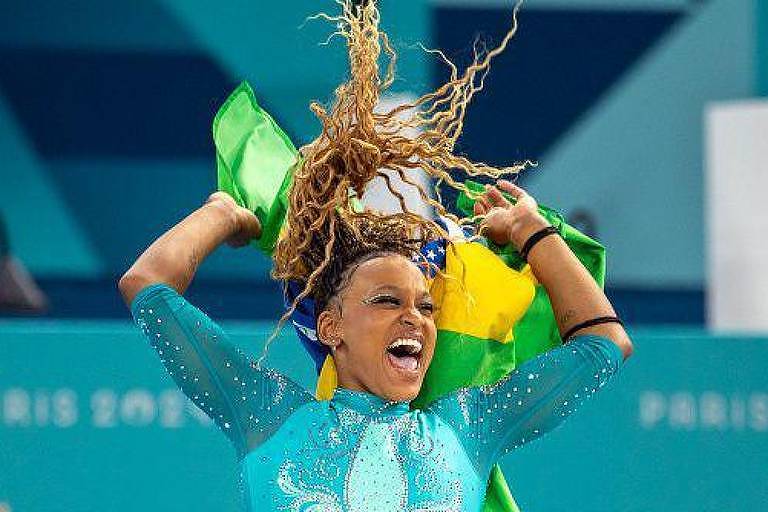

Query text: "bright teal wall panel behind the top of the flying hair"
[159, 0, 430, 144]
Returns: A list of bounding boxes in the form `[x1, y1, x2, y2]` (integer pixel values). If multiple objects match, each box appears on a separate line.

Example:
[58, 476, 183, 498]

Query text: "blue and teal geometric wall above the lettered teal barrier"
[0, 0, 768, 324]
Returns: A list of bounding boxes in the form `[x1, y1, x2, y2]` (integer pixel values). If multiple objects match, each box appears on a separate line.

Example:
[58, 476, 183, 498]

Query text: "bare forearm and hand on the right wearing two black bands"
[475, 180, 632, 358]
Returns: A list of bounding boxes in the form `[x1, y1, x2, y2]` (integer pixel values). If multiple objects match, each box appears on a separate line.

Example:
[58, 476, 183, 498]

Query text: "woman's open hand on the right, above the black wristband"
[475, 180, 549, 251]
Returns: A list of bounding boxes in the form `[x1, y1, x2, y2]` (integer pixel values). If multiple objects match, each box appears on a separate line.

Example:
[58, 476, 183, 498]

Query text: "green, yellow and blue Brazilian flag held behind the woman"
[213, 82, 605, 512]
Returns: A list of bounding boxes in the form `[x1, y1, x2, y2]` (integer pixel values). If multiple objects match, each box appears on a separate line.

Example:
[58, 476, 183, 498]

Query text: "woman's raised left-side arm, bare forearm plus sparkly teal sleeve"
[120, 194, 311, 455]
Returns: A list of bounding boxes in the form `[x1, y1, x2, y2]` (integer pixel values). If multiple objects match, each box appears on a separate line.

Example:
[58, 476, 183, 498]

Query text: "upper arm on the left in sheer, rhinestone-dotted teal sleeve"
[132, 284, 311, 453]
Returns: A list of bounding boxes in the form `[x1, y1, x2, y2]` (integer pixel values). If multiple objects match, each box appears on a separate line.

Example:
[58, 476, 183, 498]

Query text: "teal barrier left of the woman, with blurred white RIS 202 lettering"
[0, 322, 313, 512]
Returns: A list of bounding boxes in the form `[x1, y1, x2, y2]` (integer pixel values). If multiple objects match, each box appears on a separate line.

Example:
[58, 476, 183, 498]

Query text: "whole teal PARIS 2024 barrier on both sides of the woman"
[0, 321, 768, 512]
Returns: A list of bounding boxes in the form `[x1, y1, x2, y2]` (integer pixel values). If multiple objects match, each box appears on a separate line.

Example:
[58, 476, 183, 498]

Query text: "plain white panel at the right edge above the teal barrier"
[704, 101, 768, 331]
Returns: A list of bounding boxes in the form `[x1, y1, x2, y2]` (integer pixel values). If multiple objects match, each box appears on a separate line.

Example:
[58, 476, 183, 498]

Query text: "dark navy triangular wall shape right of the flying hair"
[435, 7, 683, 164]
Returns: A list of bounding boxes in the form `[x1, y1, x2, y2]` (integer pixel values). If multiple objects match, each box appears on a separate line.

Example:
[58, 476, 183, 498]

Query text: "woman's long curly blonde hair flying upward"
[272, 0, 527, 340]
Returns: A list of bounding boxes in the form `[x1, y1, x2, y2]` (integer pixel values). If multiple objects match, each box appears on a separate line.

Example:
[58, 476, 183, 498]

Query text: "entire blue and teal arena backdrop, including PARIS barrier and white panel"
[0, 0, 768, 512]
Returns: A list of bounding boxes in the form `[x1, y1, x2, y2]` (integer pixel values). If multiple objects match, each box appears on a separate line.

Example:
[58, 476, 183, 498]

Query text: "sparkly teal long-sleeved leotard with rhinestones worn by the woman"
[132, 284, 623, 512]
